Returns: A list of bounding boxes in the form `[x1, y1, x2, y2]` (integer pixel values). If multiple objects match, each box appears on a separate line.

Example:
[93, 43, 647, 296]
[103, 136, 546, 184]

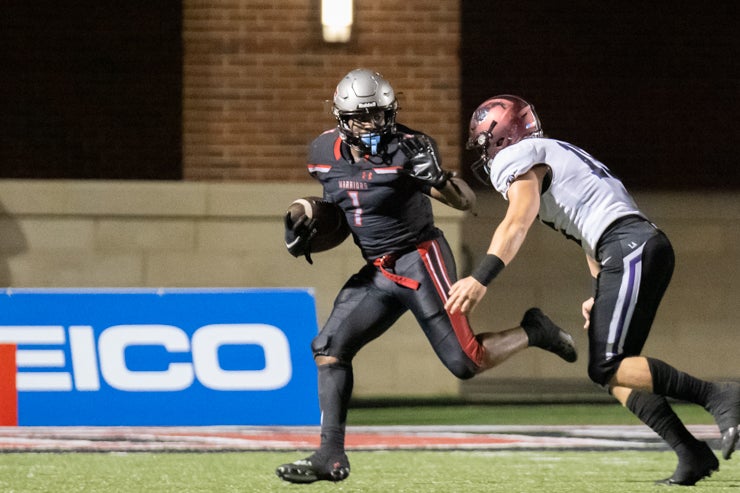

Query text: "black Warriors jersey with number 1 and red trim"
[308, 125, 439, 260]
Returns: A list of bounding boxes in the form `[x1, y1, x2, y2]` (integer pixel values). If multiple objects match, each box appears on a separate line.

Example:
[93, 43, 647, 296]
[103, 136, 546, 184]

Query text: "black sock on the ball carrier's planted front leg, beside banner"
[318, 363, 354, 459]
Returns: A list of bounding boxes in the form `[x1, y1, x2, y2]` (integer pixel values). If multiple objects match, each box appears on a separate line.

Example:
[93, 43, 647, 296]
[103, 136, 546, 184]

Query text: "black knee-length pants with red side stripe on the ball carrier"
[312, 236, 483, 379]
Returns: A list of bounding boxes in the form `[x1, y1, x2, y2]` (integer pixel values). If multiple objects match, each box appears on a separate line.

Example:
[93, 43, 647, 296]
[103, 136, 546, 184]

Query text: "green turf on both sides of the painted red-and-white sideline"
[0, 405, 740, 493]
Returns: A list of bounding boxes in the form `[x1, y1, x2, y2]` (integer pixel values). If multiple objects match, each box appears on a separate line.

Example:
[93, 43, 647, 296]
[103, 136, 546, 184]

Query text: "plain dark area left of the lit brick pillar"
[0, 0, 182, 179]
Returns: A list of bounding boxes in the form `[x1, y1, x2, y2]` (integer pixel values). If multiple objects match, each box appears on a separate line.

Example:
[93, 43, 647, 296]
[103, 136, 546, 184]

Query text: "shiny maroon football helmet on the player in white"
[465, 94, 542, 185]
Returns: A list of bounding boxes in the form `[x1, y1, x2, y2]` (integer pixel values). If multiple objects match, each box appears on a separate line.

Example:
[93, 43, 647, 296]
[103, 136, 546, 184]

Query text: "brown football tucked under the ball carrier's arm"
[287, 197, 349, 253]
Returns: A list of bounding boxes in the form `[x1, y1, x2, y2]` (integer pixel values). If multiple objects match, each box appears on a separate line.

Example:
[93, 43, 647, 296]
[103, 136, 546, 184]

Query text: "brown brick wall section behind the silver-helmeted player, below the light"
[183, 0, 460, 181]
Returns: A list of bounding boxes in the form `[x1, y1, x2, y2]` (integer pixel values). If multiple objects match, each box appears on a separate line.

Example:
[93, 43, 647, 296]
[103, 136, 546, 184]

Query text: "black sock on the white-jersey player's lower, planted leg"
[626, 390, 697, 457]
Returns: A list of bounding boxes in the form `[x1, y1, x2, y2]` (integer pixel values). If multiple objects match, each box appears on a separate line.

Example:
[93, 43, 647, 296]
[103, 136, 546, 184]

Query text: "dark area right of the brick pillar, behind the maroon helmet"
[461, 0, 740, 190]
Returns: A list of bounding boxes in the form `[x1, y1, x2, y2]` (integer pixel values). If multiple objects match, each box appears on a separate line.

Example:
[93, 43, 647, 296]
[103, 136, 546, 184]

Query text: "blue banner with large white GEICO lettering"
[0, 289, 319, 426]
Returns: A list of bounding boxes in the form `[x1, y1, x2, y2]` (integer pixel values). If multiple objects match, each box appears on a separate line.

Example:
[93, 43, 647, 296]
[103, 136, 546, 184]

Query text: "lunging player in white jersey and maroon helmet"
[445, 95, 740, 485]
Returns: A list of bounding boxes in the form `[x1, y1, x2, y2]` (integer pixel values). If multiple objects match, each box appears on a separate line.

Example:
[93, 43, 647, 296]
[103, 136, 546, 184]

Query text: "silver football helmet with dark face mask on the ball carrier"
[332, 68, 398, 155]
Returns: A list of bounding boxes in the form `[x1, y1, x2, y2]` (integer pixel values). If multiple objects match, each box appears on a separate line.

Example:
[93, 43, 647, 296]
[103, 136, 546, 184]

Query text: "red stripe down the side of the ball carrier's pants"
[416, 240, 486, 367]
